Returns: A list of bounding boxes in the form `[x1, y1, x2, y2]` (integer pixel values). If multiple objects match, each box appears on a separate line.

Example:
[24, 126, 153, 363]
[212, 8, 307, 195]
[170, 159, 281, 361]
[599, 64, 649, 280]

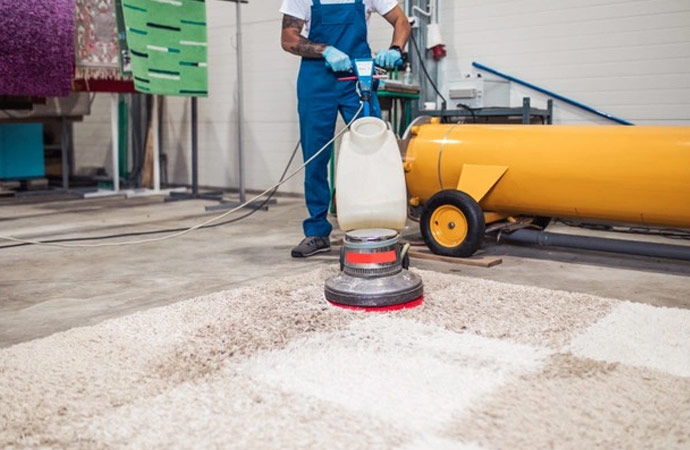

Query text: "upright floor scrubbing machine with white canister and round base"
[325, 59, 424, 311]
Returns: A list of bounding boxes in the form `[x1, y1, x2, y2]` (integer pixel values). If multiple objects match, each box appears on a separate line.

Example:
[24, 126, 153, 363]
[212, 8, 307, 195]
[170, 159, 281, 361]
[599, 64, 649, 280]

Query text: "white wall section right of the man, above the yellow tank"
[441, 0, 690, 125]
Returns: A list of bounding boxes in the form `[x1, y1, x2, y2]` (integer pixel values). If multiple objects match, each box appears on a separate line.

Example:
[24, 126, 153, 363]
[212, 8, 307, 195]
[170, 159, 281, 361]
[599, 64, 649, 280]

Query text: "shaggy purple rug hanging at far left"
[0, 0, 74, 97]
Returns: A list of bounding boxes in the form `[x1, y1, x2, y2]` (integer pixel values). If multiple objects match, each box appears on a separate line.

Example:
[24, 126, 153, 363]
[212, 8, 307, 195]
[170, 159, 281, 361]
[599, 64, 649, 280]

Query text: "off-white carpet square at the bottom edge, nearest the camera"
[78, 370, 411, 450]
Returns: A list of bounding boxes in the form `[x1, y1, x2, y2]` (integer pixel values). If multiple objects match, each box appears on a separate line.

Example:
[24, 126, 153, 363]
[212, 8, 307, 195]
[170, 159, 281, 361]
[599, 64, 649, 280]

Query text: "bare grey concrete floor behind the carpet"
[0, 197, 690, 347]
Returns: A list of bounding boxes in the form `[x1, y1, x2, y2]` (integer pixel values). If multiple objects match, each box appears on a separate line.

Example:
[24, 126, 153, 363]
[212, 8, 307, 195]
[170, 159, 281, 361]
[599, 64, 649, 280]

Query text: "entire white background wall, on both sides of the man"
[71, 0, 690, 192]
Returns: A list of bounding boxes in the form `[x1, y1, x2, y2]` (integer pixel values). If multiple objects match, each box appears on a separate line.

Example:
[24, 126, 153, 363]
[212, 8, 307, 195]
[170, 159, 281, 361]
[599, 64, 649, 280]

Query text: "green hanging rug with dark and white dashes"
[122, 0, 208, 97]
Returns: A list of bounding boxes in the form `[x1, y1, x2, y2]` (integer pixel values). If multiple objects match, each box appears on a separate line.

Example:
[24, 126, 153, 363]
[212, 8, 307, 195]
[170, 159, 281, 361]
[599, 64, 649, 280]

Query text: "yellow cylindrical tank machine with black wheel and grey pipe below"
[403, 118, 690, 259]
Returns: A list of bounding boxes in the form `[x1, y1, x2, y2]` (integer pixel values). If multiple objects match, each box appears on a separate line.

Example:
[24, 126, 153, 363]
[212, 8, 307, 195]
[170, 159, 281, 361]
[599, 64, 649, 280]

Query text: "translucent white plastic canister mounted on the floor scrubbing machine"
[335, 117, 407, 231]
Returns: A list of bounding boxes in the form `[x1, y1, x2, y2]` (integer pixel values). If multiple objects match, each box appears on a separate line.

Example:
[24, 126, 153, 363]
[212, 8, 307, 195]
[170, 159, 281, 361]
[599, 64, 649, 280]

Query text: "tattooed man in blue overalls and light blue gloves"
[280, 0, 410, 258]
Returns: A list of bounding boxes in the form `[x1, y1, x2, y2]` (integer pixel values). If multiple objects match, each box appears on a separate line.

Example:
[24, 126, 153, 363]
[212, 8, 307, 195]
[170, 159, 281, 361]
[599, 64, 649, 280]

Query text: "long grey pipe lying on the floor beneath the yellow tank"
[498, 229, 690, 261]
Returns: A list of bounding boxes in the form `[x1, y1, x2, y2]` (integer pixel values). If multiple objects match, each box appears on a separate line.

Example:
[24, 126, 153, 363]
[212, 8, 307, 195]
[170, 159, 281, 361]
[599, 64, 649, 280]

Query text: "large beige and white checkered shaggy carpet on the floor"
[0, 269, 690, 450]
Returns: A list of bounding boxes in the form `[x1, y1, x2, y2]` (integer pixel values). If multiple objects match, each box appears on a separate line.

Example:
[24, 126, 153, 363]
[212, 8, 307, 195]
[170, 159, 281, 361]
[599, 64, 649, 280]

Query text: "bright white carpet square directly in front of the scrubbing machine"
[236, 316, 549, 433]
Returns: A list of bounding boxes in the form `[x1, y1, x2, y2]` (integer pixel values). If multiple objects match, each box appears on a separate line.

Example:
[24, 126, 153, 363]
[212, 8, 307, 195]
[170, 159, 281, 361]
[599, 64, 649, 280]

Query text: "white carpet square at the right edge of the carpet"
[570, 302, 690, 378]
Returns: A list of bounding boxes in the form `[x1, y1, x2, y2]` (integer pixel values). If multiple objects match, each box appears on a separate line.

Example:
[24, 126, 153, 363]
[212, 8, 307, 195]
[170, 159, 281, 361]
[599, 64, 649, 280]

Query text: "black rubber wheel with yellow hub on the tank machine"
[419, 189, 486, 258]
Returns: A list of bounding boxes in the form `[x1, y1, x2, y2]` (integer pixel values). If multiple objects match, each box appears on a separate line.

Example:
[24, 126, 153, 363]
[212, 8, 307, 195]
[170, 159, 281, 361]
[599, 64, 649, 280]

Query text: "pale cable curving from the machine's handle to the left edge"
[0, 102, 364, 248]
